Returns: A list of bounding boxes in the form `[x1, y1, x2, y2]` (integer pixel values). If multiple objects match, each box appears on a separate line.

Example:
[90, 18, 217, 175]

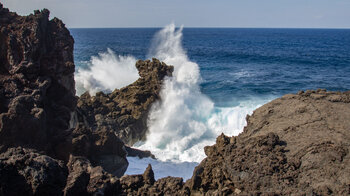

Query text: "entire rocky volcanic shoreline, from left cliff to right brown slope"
[0, 3, 350, 195]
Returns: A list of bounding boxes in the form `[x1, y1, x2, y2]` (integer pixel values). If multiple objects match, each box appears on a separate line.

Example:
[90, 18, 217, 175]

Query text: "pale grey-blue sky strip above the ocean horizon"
[0, 0, 350, 28]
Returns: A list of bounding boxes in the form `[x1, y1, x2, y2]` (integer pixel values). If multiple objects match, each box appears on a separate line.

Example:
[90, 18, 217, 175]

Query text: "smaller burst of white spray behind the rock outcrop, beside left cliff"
[75, 49, 139, 95]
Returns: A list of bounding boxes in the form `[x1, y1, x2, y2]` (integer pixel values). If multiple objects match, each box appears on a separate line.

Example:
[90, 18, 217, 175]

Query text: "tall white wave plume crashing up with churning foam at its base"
[135, 24, 268, 162]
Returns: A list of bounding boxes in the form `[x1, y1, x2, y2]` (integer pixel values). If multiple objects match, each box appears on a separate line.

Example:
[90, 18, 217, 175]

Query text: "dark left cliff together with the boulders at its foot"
[0, 4, 128, 195]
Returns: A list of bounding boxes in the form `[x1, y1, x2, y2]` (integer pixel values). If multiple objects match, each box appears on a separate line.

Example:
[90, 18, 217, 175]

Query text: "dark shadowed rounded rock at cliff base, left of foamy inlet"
[57, 124, 129, 177]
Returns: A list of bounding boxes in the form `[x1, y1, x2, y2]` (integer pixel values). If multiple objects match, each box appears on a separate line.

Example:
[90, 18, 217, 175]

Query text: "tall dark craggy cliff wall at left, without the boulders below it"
[0, 4, 76, 156]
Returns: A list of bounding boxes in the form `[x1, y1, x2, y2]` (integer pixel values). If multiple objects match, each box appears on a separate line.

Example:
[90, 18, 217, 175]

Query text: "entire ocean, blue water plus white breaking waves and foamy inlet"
[70, 24, 350, 180]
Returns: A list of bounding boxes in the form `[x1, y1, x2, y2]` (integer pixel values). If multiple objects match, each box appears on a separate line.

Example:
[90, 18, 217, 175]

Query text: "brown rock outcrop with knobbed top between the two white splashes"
[77, 59, 174, 146]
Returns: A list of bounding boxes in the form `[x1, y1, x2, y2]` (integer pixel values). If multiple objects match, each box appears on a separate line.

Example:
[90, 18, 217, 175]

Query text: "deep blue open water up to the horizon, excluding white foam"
[70, 28, 350, 106]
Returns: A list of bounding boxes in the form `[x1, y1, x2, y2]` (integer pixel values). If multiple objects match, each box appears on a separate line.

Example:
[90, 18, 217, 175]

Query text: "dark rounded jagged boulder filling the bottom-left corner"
[0, 147, 68, 195]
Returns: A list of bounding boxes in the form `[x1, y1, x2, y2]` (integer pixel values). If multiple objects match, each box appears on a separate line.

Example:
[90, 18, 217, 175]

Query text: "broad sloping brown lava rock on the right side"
[186, 90, 350, 195]
